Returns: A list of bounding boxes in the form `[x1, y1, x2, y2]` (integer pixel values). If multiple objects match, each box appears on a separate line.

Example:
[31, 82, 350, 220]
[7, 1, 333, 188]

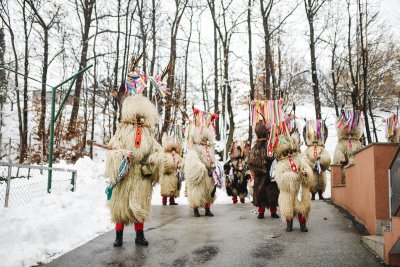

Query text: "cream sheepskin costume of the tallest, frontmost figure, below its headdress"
[105, 95, 161, 246]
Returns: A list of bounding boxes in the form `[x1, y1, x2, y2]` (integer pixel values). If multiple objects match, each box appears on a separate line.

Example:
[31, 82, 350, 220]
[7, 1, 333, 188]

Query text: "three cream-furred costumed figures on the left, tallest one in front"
[103, 59, 222, 247]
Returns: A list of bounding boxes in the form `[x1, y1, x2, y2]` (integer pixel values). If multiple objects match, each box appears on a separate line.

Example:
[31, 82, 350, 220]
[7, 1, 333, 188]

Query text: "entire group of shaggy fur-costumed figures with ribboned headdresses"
[103, 54, 400, 246]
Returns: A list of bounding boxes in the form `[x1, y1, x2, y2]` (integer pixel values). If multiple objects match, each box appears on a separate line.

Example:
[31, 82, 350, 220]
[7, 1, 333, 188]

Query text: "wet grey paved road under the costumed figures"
[47, 201, 382, 267]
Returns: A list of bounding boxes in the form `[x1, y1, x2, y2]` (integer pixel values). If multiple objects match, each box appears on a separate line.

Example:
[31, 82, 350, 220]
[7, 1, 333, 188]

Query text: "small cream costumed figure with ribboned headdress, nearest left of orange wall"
[303, 120, 331, 200]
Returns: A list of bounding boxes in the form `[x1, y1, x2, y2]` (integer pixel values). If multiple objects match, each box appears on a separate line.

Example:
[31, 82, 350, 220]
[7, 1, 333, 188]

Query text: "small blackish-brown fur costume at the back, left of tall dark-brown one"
[224, 141, 250, 204]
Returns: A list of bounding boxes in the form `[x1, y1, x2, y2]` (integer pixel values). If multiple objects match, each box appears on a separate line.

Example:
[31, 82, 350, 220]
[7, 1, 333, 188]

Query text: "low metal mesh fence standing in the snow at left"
[0, 162, 77, 207]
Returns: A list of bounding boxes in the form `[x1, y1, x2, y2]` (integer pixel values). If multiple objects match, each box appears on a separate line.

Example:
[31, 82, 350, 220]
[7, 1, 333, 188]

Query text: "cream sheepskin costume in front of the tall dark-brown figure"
[275, 125, 315, 232]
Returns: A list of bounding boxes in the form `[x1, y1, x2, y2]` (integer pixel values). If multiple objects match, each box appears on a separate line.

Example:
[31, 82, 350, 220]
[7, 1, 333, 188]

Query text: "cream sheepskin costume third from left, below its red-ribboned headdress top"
[183, 125, 216, 217]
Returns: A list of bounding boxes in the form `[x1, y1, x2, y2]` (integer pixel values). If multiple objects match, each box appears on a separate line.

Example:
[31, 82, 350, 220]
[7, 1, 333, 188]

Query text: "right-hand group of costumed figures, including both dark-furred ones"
[224, 99, 368, 232]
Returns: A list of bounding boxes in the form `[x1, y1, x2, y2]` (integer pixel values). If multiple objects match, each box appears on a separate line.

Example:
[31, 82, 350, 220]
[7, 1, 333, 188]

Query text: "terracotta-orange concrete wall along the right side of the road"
[331, 143, 398, 235]
